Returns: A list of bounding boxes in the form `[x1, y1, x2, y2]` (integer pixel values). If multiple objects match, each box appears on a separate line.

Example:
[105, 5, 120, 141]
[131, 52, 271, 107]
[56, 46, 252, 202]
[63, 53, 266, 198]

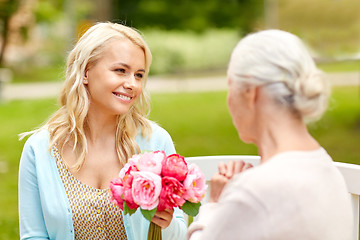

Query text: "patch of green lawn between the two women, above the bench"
[151, 92, 256, 156]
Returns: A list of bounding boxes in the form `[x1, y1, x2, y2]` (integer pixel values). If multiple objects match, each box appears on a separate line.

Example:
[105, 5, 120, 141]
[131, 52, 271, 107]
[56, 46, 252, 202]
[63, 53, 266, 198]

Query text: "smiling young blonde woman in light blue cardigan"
[19, 23, 186, 240]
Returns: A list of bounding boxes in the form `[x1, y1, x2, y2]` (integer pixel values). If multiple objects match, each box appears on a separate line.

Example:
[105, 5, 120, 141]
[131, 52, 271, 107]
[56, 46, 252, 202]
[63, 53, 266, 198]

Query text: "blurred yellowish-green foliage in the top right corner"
[278, 0, 360, 57]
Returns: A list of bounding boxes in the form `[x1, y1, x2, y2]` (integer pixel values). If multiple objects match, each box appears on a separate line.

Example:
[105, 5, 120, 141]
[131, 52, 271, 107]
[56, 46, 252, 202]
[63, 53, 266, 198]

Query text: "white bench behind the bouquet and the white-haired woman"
[186, 155, 360, 240]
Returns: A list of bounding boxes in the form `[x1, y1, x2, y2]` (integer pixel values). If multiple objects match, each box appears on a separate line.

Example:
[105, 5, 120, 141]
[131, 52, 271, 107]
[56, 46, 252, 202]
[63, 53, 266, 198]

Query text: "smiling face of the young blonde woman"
[84, 39, 145, 116]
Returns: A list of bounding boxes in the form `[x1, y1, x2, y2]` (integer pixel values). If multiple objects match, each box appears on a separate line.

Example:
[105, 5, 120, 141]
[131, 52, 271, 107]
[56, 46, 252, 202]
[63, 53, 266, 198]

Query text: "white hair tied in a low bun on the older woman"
[228, 30, 330, 122]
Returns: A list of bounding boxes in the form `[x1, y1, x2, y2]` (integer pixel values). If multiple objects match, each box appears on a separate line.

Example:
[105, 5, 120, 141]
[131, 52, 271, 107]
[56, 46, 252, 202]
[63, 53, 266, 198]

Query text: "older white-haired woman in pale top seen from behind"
[188, 30, 353, 240]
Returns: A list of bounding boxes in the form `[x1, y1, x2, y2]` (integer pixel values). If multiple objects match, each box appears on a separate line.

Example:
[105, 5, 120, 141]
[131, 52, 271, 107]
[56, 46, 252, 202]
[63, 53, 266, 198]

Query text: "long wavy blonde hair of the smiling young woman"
[22, 22, 152, 170]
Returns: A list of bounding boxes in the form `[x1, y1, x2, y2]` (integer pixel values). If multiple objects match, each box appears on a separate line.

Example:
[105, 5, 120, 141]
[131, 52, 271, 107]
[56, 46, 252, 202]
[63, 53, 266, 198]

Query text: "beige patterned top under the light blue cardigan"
[53, 147, 127, 240]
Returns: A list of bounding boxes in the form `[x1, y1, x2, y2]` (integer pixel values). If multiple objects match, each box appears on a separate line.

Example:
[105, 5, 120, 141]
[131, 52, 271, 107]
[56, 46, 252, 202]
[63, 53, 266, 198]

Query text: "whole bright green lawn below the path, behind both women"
[0, 87, 360, 240]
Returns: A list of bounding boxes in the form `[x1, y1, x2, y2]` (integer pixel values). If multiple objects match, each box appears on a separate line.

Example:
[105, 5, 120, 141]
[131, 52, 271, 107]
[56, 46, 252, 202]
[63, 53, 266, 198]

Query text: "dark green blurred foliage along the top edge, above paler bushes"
[113, 0, 264, 33]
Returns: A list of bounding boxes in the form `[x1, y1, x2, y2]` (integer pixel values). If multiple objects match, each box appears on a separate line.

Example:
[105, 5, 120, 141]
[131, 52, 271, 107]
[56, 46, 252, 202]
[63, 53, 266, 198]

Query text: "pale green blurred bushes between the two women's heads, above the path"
[143, 29, 240, 75]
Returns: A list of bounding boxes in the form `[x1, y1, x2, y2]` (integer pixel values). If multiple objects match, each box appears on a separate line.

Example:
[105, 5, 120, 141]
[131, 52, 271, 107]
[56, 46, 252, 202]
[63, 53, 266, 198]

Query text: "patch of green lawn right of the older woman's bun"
[309, 86, 360, 164]
